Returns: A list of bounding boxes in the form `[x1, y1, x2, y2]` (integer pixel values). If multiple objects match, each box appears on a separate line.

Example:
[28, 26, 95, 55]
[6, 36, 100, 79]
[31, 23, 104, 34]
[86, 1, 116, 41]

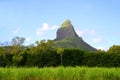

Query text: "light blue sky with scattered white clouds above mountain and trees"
[0, 0, 120, 50]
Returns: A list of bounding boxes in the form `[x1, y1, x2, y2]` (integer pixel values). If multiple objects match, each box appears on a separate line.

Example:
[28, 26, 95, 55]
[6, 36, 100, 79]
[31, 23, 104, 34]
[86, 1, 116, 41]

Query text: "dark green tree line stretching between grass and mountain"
[0, 37, 120, 67]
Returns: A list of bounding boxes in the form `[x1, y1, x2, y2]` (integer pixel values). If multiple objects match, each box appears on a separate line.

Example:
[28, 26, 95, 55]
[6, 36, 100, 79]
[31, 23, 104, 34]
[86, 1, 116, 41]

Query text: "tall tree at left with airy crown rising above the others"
[11, 36, 25, 66]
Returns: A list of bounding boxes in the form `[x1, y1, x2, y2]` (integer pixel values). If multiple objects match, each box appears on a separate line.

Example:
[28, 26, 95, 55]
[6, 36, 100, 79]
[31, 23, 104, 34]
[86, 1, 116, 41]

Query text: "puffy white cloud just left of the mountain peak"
[36, 23, 57, 36]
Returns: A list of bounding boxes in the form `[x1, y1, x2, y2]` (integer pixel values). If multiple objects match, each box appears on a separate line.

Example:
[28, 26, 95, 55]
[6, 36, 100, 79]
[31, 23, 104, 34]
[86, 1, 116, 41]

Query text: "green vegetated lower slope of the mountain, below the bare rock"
[53, 37, 96, 51]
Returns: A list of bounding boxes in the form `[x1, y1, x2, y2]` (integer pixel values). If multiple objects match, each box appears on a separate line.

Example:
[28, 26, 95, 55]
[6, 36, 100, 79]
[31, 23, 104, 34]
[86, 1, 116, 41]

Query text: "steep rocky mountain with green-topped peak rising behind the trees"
[53, 20, 96, 51]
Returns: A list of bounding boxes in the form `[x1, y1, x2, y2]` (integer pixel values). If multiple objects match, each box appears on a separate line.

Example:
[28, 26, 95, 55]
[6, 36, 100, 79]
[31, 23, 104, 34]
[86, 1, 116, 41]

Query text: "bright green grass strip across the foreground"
[0, 67, 120, 80]
